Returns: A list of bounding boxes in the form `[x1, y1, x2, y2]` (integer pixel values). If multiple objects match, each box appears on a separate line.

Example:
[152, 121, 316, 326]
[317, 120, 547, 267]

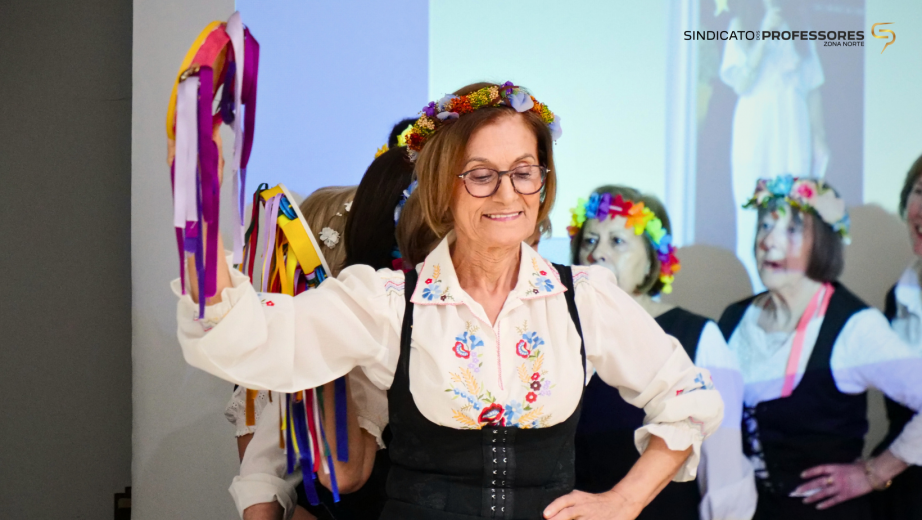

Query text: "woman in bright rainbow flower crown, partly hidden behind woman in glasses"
[568, 186, 756, 520]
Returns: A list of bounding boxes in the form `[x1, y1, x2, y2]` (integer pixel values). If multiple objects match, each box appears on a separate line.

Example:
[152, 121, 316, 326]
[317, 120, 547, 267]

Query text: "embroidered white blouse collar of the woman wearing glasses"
[410, 232, 566, 315]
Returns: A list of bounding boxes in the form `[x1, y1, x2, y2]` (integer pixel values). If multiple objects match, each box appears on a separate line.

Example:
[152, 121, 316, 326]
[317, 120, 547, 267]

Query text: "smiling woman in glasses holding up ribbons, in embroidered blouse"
[174, 82, 723, 520]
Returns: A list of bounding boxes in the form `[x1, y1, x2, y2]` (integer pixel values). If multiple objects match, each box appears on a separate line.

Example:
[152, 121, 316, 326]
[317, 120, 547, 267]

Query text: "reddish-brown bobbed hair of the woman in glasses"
[416, 83, 557, 237]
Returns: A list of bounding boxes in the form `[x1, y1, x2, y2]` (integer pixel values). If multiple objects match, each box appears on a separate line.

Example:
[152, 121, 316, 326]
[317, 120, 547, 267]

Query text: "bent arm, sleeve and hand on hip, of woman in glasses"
[545, 266, 723, 520]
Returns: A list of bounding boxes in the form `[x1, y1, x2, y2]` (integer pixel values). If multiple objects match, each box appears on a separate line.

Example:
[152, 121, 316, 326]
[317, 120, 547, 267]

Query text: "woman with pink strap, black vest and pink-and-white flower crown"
[720, 175, 922, 520]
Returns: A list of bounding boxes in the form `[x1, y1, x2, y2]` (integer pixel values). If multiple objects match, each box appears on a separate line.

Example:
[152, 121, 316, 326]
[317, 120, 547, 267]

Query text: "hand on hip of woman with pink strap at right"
[791, 462, 873, 509]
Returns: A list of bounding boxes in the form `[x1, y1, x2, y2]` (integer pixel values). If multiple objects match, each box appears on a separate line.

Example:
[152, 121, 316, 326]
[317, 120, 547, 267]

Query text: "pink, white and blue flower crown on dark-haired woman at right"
[743, 174, 851, 244]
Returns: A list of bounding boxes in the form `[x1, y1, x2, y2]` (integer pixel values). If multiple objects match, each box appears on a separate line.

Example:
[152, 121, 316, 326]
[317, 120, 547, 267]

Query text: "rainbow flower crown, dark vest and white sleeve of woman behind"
[568, 193, 756, 520]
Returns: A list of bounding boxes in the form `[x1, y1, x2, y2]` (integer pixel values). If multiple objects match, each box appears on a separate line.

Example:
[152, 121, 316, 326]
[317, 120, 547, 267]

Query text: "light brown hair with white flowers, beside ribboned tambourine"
[300, 186, 356, 276]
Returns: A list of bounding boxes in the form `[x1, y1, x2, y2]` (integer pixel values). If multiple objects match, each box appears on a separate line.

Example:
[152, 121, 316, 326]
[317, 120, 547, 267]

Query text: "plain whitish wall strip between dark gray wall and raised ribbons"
[131, 0, 243, 520]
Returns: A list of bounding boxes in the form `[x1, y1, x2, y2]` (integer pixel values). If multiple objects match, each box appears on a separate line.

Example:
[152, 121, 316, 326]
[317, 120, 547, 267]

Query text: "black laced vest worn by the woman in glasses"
[381, 265, 586, 520]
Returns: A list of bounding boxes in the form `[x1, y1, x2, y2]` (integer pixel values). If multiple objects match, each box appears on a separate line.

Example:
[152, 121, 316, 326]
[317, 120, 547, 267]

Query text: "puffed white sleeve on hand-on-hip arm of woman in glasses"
[574, 266, 724, 482]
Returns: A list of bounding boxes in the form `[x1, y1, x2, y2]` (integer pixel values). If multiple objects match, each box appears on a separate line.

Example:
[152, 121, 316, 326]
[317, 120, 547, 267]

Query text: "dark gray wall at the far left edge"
[0, 0, 132, 519]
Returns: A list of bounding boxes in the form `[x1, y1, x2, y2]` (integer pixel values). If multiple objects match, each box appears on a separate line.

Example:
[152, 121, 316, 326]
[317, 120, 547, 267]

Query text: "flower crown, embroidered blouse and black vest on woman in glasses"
[173, 83, 723, 520]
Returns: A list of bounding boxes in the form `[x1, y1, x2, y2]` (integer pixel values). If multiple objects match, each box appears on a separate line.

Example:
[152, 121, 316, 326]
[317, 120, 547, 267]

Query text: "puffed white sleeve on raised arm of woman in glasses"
[173, 254, 405, 392]
